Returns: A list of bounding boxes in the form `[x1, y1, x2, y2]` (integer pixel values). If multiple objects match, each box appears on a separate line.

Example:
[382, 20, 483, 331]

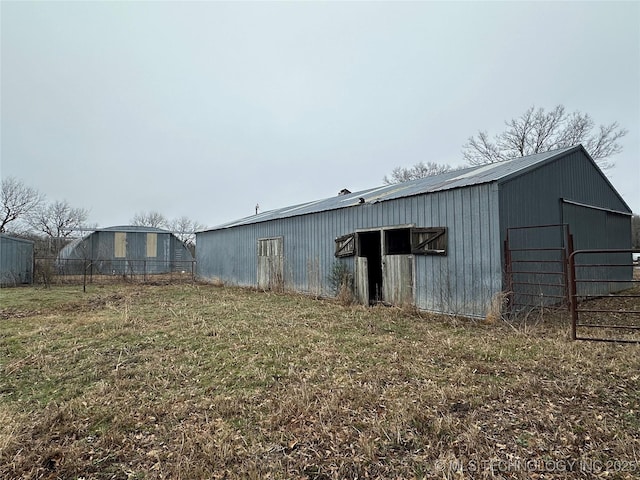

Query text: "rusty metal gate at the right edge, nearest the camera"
[568, 249, 640, 343]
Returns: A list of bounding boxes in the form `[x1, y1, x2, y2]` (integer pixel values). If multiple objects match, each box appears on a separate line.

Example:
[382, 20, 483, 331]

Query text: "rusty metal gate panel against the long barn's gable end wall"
[504, 224, 573, 313]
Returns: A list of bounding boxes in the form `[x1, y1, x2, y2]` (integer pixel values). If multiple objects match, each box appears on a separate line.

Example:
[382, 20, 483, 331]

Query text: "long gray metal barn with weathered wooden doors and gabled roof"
[196, 145, 631, 317]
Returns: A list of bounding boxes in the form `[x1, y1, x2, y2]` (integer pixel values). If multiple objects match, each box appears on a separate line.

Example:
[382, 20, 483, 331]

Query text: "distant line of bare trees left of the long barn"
[0, 177, 204, 255]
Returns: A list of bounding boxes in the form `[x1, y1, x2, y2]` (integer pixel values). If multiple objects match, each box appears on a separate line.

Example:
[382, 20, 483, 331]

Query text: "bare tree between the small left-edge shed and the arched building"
[29, 200, 89, 253]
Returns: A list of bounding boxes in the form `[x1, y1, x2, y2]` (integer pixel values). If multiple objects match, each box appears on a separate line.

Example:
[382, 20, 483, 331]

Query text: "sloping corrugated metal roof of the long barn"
[204, 145, 583, 231]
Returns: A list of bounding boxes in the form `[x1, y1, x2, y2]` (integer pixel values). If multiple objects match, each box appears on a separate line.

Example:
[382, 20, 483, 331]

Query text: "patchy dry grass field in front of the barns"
[0, 284, 640, 480]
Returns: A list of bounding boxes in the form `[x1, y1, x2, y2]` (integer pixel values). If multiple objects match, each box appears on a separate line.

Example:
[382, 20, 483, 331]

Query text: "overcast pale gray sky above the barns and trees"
[0, 1, 640, 231]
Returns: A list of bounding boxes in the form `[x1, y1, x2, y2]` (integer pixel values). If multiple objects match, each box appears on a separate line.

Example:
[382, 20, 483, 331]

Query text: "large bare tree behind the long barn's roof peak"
[462, 105, 628, 169]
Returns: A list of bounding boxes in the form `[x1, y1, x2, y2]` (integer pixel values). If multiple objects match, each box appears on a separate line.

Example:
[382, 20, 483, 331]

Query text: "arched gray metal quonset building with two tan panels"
[57, 226, 193, 274]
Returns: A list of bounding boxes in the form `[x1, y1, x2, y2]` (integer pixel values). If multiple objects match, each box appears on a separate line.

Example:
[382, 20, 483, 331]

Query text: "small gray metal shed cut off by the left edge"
[0, 233, 33, 287]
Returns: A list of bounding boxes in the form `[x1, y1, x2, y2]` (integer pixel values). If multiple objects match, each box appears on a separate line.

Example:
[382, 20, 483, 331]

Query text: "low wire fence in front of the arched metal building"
[33, 257, 196, 285]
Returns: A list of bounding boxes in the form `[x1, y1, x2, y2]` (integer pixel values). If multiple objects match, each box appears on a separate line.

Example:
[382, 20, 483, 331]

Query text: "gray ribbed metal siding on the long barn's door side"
[196, 184, 502, 316]
